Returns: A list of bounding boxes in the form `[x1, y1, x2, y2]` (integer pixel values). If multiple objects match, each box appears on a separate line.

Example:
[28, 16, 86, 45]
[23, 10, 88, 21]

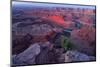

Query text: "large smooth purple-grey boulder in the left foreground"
[13, 43, 40, 65]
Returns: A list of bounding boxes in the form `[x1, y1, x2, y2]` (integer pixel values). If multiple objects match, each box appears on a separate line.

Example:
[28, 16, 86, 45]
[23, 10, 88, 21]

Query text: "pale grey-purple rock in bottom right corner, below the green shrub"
[65, 51, 96, 62]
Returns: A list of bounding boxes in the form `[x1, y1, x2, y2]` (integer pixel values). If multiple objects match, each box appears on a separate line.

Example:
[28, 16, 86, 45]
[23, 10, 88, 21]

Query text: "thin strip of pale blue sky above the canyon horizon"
[12, 1, 95, 9]
